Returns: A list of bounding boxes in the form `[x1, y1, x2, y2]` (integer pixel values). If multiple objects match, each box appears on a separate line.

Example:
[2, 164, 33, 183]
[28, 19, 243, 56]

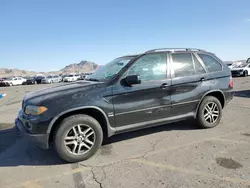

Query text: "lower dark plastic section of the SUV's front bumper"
[15, 117, 49, 149]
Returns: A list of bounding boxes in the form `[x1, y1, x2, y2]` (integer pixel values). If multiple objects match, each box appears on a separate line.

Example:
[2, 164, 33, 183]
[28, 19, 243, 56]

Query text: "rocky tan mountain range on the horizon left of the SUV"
[0, 61, 100, 77]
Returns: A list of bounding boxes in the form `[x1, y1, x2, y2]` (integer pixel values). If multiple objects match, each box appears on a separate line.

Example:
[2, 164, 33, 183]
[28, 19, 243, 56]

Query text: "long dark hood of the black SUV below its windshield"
[24, 81, 103, 101]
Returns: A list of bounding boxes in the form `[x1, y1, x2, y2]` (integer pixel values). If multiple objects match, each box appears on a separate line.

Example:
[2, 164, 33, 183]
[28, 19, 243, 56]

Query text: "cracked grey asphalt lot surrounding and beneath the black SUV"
[0, 77, 250, 188]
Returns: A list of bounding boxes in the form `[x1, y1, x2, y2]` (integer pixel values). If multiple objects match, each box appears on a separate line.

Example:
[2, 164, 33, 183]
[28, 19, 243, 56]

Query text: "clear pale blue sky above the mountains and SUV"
[0, 0, 250, 71]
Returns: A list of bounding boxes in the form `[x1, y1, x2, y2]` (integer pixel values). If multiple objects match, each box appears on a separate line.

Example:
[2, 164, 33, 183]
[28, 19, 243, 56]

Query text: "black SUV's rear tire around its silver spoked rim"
[196, 96, 222, 128]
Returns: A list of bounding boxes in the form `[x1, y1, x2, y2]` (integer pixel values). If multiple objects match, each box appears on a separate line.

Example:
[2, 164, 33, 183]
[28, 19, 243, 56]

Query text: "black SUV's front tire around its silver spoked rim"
[53, 114, 103, 162]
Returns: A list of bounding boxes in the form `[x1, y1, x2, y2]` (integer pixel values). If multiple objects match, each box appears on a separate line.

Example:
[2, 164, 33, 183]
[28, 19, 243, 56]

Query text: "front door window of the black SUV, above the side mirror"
[127, 53, 167, 82]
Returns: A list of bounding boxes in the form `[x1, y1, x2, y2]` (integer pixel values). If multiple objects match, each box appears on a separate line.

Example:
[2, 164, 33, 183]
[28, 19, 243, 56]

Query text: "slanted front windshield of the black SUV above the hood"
[86, 57, 133, 81]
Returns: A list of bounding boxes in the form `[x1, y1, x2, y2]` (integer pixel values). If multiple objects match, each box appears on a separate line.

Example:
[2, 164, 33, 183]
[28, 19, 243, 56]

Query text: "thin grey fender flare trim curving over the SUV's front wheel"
[47, 106, 115, 137]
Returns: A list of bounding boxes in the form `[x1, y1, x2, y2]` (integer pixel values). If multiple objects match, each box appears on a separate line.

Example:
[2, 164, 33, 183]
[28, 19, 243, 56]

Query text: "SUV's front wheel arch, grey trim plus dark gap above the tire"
[47, 106, 114, 142]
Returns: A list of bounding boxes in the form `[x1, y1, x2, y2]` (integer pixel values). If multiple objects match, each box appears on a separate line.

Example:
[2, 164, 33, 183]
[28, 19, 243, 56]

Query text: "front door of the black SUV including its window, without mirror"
[113, 52, 171, 129]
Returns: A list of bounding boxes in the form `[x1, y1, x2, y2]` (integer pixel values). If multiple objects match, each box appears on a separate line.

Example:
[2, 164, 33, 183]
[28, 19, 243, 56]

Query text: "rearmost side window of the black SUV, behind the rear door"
[199, 54, 222, 72]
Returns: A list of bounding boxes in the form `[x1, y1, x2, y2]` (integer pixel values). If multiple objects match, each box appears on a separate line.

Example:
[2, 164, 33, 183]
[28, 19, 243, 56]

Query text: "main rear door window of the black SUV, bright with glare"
[172, 53, 195, 77]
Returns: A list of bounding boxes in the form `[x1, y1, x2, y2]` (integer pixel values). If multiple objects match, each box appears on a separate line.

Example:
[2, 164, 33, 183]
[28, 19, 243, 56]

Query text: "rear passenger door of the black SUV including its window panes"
[170, 52, 211, 116]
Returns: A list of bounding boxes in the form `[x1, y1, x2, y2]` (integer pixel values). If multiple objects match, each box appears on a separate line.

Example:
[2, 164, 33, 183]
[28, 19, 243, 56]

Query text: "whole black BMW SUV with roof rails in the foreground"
[15, 49, 233, 162]
